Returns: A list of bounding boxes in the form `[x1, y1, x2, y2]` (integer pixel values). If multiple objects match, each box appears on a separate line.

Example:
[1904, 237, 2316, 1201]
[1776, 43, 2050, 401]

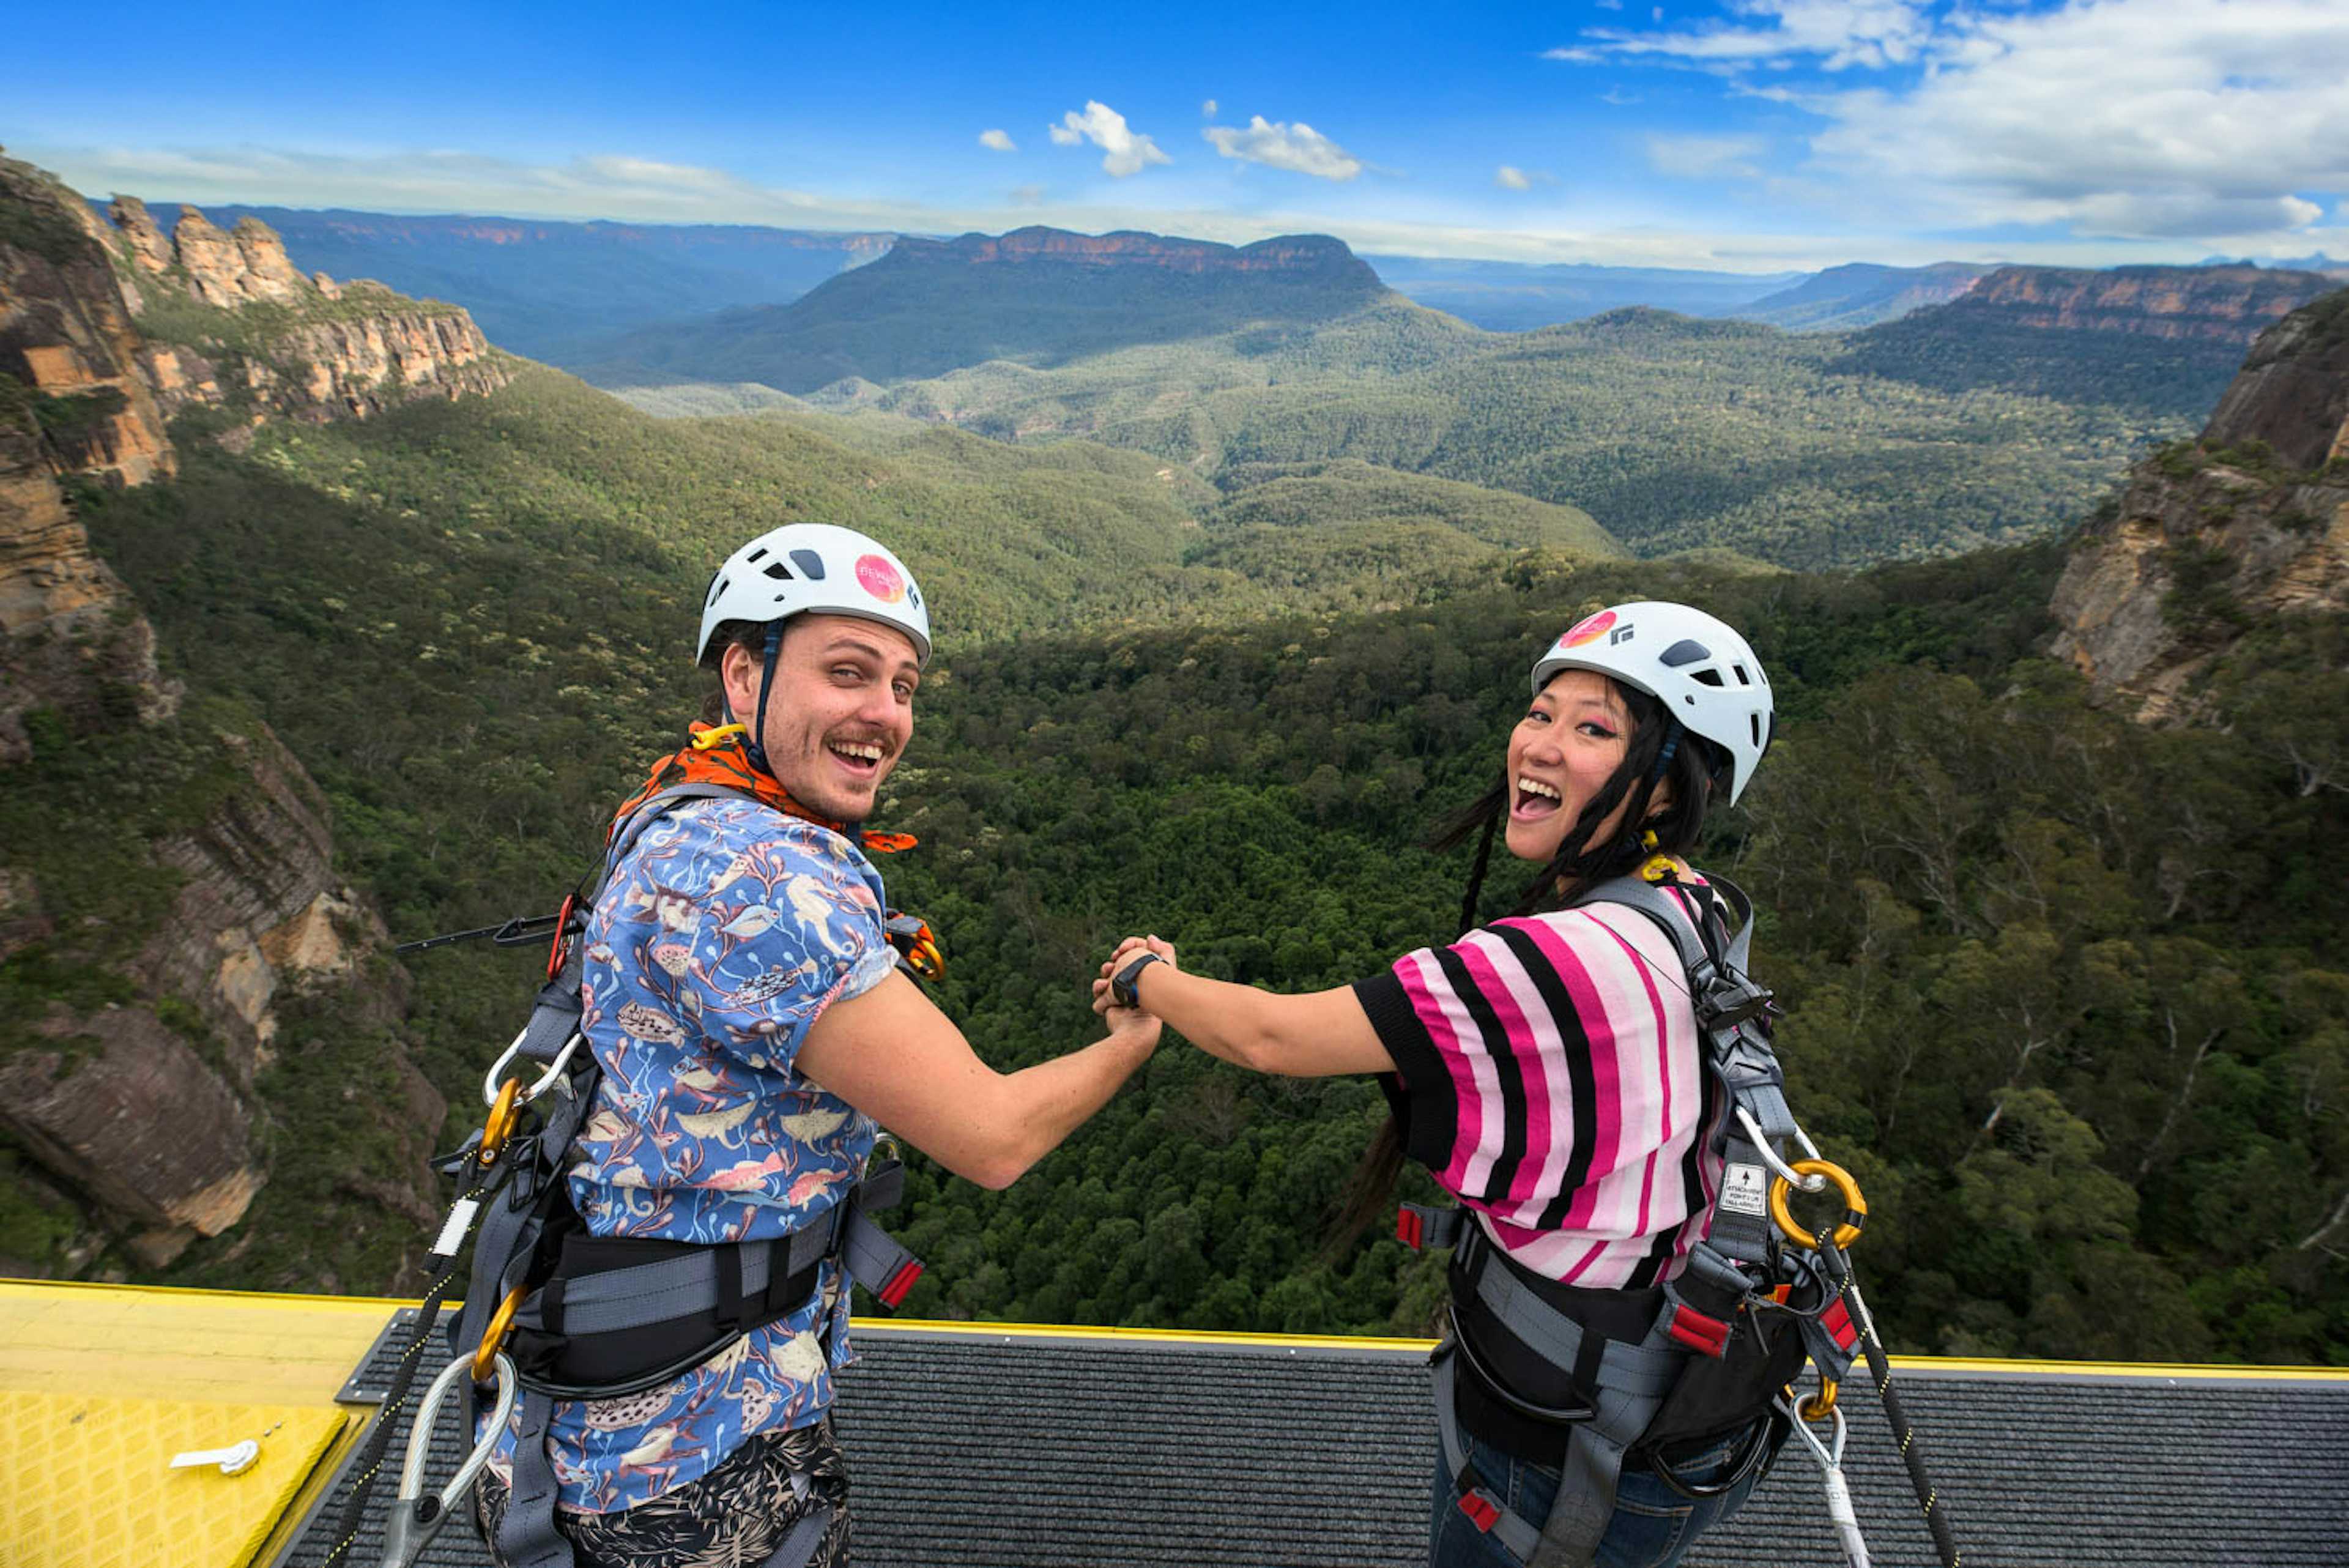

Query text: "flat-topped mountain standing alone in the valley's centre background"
[582, 228, 1402, 395]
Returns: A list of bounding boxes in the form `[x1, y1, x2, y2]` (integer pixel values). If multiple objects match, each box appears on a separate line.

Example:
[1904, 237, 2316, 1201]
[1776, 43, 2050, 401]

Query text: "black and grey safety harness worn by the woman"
[1398, 860, 1868, 1568]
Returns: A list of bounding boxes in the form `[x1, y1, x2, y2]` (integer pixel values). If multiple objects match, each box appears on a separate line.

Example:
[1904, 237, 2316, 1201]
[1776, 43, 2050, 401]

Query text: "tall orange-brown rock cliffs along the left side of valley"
[0, 160, 453, 1286]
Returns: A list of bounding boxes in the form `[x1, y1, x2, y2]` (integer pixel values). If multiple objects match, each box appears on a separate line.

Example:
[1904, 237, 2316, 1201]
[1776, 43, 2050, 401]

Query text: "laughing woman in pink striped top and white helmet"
[1094, 604, 1776, 1568]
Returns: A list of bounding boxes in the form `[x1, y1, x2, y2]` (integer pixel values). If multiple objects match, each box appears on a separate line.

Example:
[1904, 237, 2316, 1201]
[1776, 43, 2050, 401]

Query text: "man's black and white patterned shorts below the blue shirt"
[475, 1415, 848, 1568]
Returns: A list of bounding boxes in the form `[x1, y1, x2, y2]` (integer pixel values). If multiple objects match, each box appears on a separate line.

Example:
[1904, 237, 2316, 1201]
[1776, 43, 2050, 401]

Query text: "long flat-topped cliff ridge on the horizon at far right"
[1947, 266, 2340, 343]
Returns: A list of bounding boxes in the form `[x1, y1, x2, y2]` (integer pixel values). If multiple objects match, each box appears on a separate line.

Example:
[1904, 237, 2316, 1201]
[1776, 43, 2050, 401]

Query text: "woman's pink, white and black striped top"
[1356, 893, 1726, 1291]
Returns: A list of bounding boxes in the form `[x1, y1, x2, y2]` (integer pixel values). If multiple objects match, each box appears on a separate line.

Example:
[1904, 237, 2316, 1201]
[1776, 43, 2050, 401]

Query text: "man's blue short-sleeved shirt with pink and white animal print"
[493, 797, 897, 1514]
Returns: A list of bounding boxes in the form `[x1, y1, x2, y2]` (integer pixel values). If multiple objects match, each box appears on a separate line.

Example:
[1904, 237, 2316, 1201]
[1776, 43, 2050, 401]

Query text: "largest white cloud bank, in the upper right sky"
[1546, 0, 2349, 251]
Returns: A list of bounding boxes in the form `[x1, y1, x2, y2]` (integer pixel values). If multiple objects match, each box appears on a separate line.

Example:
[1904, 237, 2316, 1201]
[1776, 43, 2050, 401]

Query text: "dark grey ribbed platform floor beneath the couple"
[289, 1326, 2349, 1568]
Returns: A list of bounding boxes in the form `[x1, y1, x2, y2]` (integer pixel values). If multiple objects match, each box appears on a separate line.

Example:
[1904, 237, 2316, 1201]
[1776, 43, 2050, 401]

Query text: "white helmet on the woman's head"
[1534, 600, 1771, 804]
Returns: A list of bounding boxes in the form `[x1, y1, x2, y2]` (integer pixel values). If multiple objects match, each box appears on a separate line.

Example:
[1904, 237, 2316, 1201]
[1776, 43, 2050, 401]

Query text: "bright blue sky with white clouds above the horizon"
[0, 0, 2349, 273]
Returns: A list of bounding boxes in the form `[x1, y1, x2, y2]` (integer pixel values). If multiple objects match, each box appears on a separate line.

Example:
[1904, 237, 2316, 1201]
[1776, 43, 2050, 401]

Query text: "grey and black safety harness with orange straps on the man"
[350, 752, 944, 1568]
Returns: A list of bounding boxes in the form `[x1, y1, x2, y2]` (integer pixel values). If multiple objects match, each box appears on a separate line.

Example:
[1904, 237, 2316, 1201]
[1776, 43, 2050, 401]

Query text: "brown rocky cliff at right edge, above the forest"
[2055, 289, 2349, 722]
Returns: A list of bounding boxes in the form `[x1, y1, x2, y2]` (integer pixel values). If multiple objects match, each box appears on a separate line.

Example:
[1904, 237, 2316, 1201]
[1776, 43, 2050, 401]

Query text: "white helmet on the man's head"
[693, 522, 930, 665]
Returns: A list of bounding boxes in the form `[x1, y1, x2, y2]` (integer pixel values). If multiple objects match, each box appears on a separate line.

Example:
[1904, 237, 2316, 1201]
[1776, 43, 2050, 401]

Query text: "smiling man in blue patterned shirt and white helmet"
[479, 524, 1158, 1568]
